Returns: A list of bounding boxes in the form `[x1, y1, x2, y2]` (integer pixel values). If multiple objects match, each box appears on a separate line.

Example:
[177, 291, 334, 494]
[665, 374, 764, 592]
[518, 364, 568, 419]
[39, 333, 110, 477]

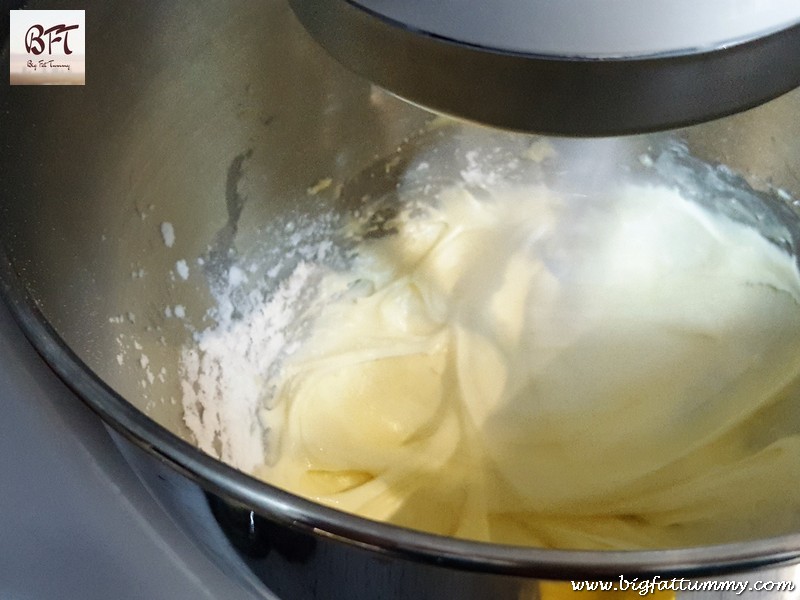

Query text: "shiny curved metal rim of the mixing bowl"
[0, 251, 800, 580]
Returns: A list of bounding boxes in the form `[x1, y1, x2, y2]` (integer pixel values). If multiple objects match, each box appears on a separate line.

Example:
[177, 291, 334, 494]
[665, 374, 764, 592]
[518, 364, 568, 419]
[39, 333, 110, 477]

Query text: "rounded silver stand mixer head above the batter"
[290, 0, 800, 136]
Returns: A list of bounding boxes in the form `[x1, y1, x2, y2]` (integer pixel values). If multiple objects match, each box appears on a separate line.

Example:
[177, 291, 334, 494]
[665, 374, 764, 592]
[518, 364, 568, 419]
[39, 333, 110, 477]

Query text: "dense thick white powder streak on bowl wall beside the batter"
[180, 263, 320, 472]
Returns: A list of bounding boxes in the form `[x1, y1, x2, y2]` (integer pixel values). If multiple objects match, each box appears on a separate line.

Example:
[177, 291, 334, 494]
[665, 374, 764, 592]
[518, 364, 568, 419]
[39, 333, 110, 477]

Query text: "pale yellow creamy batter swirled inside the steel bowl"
[260, 185, 800, 548]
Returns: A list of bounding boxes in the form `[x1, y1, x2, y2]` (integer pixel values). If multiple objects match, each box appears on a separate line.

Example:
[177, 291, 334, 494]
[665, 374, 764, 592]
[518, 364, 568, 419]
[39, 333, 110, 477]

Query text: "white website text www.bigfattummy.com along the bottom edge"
[570, 575, 797, 596]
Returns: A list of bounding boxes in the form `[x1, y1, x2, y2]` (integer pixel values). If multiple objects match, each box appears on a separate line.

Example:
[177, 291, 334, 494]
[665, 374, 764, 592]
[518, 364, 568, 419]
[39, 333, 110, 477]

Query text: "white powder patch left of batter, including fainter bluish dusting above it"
[177, 209, 342, 473]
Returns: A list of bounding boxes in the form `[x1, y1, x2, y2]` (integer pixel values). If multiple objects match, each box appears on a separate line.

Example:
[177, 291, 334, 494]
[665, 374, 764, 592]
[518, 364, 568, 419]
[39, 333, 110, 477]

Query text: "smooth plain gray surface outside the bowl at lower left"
[0, 300, 260, 600]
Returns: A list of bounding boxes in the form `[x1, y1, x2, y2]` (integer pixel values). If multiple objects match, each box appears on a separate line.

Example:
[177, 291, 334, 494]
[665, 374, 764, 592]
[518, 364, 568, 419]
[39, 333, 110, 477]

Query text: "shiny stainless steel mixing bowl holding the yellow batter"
[0, 0, 800, 598]
